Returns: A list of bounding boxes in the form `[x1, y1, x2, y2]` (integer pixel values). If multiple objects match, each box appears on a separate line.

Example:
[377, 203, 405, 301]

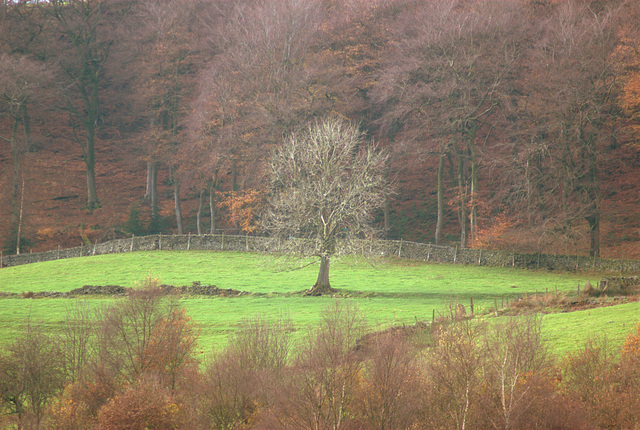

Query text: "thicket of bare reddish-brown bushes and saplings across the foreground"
[0, 282, 640, 430]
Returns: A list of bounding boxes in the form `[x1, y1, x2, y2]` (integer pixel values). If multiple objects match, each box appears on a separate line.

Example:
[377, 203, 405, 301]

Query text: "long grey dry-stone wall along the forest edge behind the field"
[0, 234, 640, 273]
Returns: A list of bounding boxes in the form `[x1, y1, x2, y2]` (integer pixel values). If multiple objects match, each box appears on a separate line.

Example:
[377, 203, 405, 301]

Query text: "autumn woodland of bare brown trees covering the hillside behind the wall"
[0, 0, 640, 258]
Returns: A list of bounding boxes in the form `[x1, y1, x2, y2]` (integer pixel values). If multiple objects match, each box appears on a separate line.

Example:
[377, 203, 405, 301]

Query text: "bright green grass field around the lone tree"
[0, 251, 640, 351]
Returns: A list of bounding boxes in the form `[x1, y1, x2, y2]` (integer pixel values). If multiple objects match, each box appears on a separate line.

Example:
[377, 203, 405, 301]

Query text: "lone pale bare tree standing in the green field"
[263, 117, 391, 295]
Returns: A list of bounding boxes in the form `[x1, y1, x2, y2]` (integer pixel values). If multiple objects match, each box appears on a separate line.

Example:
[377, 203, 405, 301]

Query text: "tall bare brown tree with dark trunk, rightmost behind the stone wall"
[527, 0, 637, 257]
